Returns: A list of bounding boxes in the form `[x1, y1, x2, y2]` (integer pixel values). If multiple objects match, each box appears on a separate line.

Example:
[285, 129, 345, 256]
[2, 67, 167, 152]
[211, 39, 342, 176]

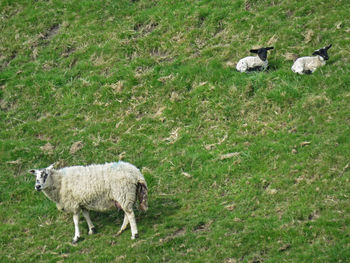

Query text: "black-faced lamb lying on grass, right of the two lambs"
[292, 44, 332, 74]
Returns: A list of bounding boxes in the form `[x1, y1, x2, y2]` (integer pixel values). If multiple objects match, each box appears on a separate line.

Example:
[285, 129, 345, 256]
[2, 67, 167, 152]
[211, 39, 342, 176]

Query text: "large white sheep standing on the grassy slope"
[29, 161, 148, 243]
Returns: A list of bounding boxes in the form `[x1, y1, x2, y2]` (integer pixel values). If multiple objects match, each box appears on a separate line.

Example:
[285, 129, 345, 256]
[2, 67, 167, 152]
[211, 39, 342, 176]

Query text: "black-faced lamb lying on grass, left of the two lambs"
[236, 47, 273, 72]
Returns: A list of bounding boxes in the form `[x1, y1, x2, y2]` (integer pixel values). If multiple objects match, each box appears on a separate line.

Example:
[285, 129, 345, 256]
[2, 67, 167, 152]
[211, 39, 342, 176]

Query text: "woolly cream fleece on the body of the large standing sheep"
[48, 161, 145, 213]
